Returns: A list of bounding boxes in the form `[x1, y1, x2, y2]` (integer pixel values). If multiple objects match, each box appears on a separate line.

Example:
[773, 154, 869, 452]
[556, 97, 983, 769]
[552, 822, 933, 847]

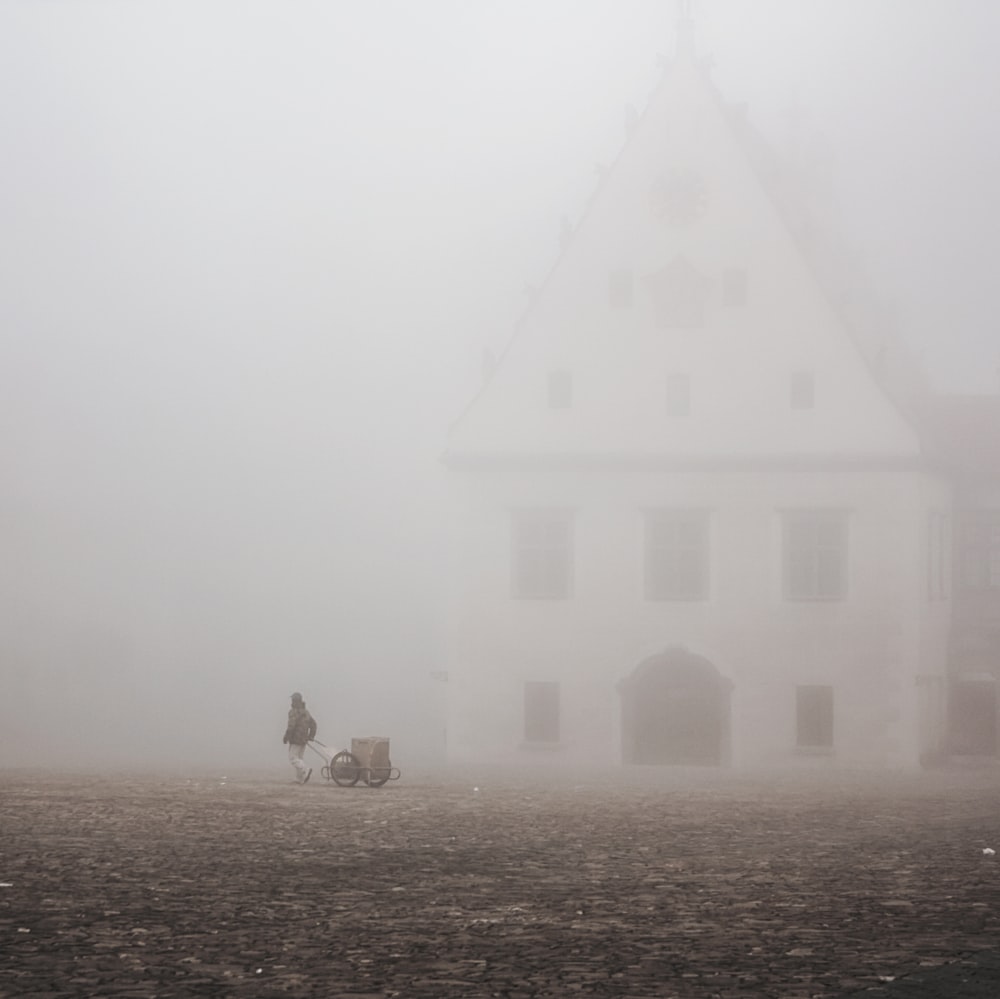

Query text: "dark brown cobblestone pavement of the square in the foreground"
[0, 768, 1000, 999]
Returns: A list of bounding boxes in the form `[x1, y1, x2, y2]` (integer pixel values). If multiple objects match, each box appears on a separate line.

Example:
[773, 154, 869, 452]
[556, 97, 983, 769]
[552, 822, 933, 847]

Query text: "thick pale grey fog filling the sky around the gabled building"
[0, 0, 1000, 771]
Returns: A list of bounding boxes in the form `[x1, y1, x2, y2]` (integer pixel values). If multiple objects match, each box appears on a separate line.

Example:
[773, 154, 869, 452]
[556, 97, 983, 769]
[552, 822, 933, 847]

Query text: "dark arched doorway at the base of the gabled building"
[621, 648, 732, 766]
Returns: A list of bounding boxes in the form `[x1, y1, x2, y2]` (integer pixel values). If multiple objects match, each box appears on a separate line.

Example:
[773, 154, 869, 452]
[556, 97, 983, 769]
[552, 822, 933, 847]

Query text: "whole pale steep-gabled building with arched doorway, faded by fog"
[447, 23, 984, 766]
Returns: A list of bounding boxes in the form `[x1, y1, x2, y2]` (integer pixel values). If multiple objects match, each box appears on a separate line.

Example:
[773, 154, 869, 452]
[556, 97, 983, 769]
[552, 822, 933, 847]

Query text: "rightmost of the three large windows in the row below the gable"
[783, 510, 847, 600]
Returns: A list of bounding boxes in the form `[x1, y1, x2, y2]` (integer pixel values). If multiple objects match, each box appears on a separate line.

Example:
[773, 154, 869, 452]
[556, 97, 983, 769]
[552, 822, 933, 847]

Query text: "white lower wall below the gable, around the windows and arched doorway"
[449, 470, 948, 765]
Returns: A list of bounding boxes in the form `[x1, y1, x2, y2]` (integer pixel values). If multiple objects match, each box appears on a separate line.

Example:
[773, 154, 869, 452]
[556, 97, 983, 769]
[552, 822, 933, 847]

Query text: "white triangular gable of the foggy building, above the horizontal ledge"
[448, 35, 919, 461]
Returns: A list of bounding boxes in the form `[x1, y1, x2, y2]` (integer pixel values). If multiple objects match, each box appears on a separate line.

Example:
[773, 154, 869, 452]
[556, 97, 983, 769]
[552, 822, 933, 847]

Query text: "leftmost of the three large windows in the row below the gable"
[511, 510, 573, 600]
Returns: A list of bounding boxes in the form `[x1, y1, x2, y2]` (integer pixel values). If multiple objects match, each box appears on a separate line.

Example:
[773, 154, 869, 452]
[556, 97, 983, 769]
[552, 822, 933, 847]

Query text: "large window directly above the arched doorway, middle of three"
[645, 510, 708, 600]
